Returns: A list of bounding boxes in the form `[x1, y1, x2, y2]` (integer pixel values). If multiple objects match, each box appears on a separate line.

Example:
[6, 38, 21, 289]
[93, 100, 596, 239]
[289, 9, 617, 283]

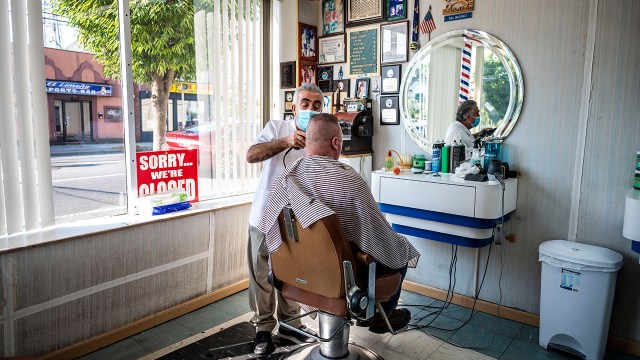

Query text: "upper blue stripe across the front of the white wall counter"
[378, 203, 510, 229]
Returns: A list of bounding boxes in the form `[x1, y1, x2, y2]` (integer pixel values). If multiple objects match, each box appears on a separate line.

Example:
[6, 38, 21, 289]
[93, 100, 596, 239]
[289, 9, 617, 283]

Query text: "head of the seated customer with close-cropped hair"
[305, 113, 342, 160]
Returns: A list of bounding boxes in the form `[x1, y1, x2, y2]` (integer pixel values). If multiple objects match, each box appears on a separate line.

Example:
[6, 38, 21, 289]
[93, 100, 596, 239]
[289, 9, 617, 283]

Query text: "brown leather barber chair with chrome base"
[271, 207, 402, 359]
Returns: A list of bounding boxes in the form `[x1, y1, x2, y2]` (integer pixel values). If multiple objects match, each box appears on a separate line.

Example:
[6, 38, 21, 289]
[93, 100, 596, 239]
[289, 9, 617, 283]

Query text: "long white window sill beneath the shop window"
[0, 194, 253, 254]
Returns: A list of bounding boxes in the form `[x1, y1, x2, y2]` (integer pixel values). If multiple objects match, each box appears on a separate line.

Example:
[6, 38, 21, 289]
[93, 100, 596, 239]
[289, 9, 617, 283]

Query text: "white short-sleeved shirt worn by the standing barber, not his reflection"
[249, 120, 304, 227]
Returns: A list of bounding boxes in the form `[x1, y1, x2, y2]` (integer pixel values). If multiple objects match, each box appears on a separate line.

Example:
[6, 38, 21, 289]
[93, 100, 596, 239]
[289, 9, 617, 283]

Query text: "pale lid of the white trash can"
[539, 240, 623, 270]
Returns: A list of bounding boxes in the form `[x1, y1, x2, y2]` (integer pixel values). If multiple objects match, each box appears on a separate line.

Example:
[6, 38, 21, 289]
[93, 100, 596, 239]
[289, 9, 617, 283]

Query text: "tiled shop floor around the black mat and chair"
[80, 290, 638, 360]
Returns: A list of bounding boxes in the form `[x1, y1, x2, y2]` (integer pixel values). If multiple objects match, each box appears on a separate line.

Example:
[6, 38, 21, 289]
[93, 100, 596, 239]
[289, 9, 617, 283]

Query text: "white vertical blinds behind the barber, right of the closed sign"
[195, 0, 262, 198]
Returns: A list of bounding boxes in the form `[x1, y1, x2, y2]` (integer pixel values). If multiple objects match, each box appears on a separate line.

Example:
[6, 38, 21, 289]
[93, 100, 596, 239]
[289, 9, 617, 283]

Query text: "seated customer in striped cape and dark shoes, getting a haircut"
[258, 113, 420, 333]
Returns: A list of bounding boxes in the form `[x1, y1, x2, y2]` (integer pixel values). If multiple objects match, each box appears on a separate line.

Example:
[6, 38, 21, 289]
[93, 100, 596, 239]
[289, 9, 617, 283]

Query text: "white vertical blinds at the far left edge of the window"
[0, 0, 54, 235]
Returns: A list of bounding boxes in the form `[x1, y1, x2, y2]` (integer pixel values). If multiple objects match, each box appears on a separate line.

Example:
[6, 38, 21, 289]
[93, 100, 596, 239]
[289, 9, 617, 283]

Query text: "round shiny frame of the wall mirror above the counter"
[400, 29, 524, 153]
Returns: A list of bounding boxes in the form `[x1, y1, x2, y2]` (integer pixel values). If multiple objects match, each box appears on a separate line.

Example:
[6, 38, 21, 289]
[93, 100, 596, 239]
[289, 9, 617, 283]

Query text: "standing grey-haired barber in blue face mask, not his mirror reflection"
[247, 83, 323, 355]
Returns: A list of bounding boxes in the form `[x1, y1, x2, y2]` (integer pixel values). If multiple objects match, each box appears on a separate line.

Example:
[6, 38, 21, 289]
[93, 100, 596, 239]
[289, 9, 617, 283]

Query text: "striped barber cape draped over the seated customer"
[258, 156, 420, 269]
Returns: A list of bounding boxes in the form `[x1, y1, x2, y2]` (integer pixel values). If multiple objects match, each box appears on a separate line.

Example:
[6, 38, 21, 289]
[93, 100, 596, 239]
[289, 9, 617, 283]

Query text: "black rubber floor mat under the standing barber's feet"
[159, 322, 306, 360]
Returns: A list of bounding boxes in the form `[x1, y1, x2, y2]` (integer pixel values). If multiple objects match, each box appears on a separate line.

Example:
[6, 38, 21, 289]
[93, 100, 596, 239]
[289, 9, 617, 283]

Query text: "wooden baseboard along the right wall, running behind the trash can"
[402, 280, 640, 356]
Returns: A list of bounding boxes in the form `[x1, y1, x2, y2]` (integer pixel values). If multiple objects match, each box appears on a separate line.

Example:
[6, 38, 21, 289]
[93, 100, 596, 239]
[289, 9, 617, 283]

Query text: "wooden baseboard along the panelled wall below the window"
[41, 279, 249, 359]
